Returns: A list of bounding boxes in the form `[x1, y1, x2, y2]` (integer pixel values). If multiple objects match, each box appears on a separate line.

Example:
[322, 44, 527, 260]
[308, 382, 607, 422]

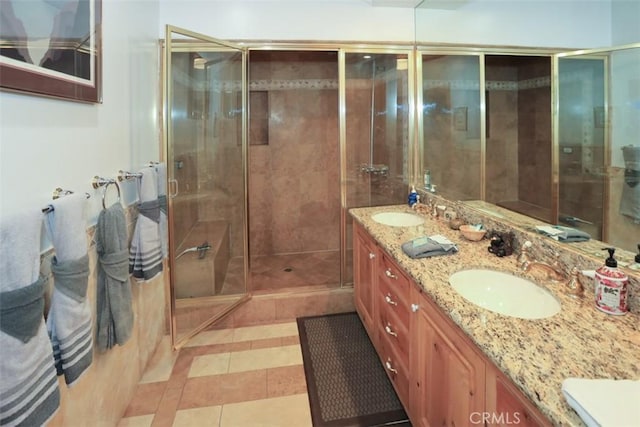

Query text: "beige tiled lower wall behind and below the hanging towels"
[41, 208, 169, 427]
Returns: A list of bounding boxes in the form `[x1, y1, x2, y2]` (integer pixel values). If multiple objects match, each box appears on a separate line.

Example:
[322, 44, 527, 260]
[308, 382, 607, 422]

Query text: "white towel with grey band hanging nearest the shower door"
[129, 168, 162, 280]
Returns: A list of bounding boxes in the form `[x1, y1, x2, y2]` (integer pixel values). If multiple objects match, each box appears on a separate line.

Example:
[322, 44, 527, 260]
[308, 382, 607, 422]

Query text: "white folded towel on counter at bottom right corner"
[562, 378, 640, 427]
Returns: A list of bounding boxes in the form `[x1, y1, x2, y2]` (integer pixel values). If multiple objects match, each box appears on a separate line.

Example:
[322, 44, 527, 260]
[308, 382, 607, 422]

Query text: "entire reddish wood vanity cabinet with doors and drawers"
[353, 222, 551, 427]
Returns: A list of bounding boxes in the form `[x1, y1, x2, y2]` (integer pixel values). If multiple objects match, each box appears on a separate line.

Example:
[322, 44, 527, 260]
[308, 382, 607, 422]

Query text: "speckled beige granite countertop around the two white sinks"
[350, 205, 640, 426]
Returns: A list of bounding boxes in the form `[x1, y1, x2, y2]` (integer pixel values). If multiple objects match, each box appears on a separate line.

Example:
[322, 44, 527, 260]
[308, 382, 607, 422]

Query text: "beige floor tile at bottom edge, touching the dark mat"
[220, 394, 312, 427]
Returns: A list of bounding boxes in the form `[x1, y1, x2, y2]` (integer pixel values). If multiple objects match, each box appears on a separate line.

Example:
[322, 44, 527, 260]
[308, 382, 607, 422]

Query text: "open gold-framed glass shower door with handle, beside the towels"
[164, 26, 248, 346]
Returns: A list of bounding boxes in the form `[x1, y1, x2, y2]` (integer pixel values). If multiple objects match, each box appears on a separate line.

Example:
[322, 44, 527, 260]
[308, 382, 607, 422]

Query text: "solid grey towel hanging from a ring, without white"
[96, 203, 133, 350]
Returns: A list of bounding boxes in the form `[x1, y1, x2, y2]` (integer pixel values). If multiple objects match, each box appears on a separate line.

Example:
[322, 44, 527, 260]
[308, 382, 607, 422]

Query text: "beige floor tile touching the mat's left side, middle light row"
[229, 345, 302, 372]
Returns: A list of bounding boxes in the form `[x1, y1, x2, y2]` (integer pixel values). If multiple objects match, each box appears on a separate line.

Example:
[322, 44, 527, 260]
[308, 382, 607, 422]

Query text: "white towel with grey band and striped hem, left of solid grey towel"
[45, 194, 93, 386]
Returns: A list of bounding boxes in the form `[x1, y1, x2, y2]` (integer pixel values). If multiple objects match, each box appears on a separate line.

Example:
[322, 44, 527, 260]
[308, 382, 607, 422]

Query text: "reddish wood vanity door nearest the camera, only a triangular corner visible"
[485, 364, 551, 427]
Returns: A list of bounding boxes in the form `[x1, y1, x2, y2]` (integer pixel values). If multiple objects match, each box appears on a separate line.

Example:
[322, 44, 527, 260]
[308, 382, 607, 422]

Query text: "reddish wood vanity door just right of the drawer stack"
[410, 291, 485, 427]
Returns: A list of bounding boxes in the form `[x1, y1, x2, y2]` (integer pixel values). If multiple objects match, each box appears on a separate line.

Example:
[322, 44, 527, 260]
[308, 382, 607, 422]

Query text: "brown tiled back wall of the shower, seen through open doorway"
[249, 52, 340, 256]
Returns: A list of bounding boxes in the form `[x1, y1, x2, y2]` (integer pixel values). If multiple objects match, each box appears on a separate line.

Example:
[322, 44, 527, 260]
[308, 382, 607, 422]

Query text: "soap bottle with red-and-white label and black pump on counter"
[594, 248, 629, 315]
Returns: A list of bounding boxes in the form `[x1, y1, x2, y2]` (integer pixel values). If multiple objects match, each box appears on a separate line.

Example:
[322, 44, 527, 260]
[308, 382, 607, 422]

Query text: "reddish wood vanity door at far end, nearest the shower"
[353, 223, 378, 343]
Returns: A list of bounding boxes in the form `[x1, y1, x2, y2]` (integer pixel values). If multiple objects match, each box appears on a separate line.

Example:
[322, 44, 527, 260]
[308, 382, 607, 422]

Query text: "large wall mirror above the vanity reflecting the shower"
[417, 43, 640, 258]
